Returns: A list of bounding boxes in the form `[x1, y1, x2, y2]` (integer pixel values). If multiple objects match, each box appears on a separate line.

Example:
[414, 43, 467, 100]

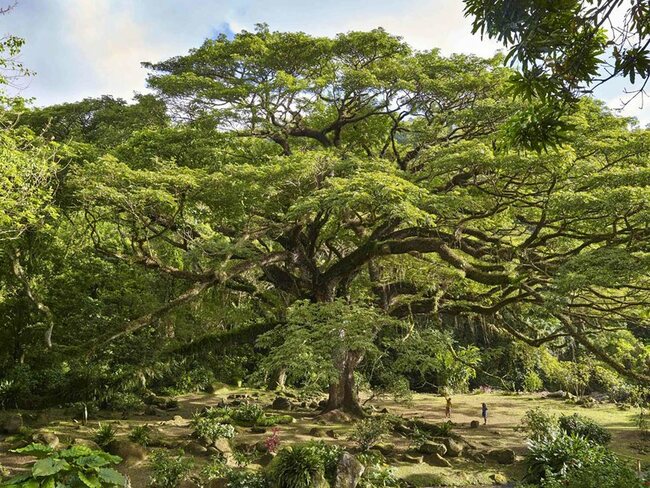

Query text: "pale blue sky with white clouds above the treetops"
[0, 0, 650, 126]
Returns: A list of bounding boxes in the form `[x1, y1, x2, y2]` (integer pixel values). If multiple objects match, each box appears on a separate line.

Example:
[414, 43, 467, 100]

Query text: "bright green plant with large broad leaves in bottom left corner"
[2, 444, 126, 488]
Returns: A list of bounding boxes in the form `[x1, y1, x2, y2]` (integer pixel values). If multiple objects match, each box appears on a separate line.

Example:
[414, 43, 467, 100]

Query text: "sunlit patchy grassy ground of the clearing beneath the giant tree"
[0, 388, 650, 487]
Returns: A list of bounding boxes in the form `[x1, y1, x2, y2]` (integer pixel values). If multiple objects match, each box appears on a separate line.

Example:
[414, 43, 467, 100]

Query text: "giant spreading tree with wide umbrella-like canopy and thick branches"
[64, 27, 650, 412]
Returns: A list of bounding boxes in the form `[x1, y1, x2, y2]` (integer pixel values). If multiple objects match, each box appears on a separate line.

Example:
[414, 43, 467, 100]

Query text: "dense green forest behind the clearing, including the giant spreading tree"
[0, 17, 650, 488]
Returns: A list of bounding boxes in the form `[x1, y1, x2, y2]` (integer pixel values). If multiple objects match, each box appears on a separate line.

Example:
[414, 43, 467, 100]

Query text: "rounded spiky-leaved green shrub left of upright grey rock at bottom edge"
[269, 446, 325, 488]
